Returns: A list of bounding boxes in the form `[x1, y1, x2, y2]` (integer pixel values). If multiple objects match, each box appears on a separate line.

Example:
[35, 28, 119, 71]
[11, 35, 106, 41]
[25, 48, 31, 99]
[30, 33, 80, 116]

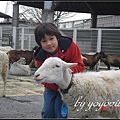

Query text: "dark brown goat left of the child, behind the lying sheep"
[7, 46, 37, 65]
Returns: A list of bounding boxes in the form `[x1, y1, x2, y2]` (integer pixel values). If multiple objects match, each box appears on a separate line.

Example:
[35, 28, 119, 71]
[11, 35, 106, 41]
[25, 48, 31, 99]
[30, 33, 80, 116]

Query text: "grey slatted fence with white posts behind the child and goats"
[0, 27, 120, 67]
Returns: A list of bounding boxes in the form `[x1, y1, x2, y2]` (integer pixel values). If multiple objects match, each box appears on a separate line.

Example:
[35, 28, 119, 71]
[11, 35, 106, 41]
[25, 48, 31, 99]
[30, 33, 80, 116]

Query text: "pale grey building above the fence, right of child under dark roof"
[59, 15, 120, 28]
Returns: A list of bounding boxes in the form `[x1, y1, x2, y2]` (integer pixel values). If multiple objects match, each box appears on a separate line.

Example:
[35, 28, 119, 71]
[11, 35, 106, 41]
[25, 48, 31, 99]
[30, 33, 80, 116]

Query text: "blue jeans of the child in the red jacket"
[41, 88, 65, 118]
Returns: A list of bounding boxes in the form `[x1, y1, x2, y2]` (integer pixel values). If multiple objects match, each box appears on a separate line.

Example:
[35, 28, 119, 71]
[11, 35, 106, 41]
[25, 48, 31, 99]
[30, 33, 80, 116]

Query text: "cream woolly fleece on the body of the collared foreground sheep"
[64, 71, 120, 118]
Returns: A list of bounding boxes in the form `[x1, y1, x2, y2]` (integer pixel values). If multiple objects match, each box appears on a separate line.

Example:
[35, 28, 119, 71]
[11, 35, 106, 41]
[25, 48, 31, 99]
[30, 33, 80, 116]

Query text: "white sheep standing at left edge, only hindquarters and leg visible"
[0, 51, 9, 97]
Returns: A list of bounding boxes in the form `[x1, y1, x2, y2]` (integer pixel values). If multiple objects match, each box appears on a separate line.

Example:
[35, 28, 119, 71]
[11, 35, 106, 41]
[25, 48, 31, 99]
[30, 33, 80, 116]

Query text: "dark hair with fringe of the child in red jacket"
[35, 23, 61, 46]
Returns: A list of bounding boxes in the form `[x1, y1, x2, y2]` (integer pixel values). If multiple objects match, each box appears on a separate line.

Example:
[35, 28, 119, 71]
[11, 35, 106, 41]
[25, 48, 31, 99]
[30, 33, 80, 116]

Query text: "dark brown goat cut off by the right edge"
[101, 54, 120, 70]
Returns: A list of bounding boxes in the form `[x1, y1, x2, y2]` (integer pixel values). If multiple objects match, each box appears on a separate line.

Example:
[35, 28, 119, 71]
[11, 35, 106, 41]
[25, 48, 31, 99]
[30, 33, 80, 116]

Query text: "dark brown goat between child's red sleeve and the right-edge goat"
[82, 52, 105, 70]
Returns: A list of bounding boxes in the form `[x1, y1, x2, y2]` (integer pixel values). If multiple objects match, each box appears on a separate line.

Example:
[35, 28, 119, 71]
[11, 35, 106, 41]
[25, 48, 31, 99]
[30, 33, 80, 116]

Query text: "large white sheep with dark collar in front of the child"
[34, 57, 120, 118]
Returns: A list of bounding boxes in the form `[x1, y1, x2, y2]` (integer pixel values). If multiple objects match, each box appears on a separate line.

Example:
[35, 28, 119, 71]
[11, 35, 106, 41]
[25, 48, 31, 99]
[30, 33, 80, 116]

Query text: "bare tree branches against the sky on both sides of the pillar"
[20, 5, 75, 23]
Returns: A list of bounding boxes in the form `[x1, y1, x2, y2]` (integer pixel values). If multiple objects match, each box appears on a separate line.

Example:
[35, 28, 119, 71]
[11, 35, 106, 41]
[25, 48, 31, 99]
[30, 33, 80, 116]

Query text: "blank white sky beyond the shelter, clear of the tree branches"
[0, 1, 91, 21]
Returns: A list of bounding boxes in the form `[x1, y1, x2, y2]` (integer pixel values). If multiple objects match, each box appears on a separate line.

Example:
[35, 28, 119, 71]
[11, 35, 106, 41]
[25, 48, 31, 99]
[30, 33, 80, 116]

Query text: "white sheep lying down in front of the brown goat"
[9, 57, 31, 76]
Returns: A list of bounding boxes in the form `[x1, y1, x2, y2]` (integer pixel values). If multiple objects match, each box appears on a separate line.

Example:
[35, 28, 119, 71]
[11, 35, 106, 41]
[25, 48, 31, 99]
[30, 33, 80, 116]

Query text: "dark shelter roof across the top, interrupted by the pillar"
[18, 0, 120, 15]
